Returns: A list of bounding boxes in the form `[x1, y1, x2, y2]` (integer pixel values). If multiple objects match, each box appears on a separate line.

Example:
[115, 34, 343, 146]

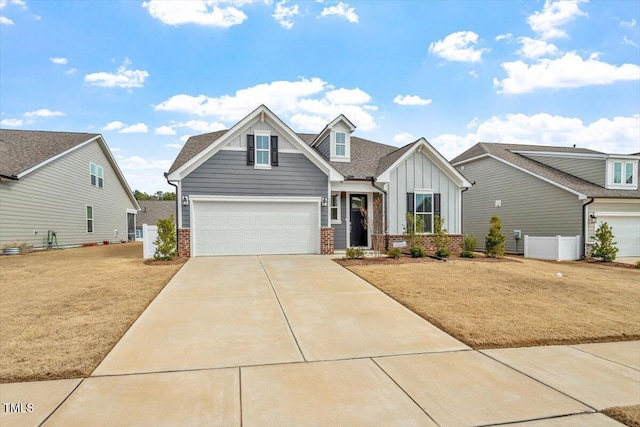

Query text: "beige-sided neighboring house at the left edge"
[0, 129, 140, 247]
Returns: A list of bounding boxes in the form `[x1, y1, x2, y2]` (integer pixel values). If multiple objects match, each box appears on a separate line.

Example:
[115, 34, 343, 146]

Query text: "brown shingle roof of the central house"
[169, 130, 411, 179]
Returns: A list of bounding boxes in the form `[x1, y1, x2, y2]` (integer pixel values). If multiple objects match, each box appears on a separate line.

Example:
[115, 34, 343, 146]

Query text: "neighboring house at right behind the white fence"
[451, 143, 640, 256]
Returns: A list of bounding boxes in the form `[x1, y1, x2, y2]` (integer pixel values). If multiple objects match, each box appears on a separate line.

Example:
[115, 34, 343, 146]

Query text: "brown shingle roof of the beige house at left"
[0, 129, 99, 176]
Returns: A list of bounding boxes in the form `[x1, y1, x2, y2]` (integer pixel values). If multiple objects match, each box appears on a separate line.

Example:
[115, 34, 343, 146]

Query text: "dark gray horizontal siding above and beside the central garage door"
[182, 151, 328, 228]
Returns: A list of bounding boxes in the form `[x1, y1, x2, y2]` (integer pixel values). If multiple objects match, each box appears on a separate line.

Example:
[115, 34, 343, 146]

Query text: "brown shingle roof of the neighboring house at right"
[451, 142, 640, 198]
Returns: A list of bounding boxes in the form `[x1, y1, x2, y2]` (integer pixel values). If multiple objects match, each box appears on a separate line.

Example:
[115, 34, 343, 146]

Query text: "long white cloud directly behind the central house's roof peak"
[155, 77, 378, 132]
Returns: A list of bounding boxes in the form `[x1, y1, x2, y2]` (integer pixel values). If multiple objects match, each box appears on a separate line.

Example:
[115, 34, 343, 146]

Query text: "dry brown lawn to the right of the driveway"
[348, 258, 640, 349]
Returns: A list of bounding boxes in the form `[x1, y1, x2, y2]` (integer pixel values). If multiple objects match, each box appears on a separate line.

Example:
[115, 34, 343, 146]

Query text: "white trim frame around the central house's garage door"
[189, 195, 322, 257]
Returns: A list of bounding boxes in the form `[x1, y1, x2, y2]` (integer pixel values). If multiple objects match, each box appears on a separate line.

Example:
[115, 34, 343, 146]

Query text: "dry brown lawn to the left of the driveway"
[0, 243, 182, 382]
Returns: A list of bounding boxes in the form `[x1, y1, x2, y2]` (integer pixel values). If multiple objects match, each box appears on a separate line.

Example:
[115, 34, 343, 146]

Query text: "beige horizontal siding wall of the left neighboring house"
[0, 141, 136, 247]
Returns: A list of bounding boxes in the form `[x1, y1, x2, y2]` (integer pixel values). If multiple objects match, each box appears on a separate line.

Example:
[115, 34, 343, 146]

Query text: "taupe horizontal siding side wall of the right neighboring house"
[457, 158, 583, 253]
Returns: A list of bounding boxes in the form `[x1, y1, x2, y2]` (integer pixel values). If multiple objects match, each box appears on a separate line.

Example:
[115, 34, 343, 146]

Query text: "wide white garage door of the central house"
[191, 199, 320, 256]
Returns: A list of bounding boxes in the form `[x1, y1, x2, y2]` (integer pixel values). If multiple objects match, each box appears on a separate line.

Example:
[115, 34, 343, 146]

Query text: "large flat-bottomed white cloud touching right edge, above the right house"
[493, 52, 640, 94]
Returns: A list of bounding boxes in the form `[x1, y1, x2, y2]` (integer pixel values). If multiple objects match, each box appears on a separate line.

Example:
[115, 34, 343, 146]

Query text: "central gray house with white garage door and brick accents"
[167, 105, 471, 256]
